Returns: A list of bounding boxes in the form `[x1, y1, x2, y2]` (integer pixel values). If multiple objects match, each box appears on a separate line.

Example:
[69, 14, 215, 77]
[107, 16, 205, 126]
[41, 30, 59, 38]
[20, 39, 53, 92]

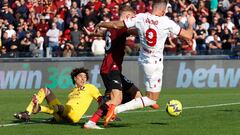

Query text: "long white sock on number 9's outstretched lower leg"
[115, 96, 156, 114]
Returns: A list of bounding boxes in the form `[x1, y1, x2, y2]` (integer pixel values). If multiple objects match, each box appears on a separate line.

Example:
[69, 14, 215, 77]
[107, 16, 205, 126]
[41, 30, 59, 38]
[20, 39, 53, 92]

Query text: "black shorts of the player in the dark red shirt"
[101, 70, 137, 103]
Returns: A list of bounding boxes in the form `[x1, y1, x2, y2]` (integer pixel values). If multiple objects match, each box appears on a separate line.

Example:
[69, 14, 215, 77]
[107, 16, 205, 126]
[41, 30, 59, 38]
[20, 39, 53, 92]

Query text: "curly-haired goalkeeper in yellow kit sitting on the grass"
[14, 68, 102, 123]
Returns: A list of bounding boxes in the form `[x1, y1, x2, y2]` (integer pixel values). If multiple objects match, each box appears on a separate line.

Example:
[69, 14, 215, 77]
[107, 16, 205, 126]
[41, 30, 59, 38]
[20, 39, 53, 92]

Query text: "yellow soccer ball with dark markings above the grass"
[166, 99, 182, 117]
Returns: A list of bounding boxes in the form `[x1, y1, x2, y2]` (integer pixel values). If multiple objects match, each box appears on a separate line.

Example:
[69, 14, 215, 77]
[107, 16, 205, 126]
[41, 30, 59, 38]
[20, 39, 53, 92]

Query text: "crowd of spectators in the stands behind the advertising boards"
[0, 0, 240, 57]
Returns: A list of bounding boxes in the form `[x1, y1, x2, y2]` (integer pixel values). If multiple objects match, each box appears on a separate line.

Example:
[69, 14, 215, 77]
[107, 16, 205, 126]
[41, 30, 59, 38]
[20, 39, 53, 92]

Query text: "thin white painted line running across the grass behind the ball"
[0, 102, 240, 127]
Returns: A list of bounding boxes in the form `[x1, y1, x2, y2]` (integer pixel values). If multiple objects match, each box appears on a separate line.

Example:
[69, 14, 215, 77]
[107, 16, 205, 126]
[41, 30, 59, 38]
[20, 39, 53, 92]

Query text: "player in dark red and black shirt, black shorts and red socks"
[84, 6, 158, 129]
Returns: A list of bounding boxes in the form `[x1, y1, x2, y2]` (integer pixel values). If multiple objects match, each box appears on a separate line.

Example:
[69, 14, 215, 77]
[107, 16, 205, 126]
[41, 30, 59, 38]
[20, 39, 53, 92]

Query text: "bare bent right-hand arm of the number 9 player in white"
[179, 16, 196, 40]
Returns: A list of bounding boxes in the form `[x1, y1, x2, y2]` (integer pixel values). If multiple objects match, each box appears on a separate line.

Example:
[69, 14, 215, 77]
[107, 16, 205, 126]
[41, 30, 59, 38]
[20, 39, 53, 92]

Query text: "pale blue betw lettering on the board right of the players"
[176, 62, 240, 88]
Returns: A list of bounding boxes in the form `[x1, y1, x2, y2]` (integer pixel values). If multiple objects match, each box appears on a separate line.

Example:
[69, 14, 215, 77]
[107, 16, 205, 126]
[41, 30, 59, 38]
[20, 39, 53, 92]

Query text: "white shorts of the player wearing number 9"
[139, 58, 163, 92]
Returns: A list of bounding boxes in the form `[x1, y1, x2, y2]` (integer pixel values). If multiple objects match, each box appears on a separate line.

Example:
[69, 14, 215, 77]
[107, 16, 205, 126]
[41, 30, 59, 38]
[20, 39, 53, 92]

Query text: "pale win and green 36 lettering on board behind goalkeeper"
[0, 64, 101, 90]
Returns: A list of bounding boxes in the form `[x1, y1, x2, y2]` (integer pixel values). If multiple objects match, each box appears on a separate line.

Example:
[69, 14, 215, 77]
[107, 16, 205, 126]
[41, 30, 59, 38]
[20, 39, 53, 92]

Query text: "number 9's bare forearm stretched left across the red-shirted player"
[96, 21, 125, 29]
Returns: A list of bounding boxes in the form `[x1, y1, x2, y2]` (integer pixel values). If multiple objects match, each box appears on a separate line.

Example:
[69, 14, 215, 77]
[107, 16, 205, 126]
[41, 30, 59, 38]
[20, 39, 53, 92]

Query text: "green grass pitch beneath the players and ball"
[0, 89, 240, 135]
